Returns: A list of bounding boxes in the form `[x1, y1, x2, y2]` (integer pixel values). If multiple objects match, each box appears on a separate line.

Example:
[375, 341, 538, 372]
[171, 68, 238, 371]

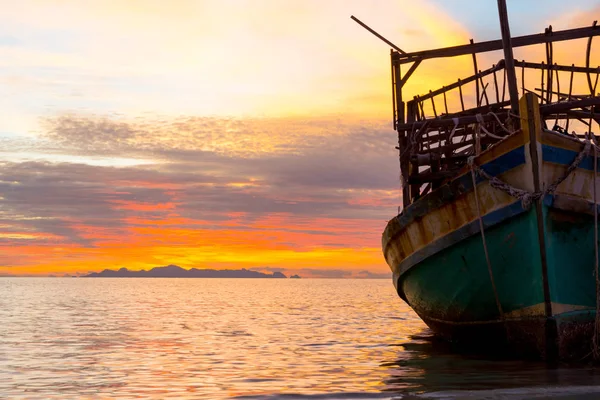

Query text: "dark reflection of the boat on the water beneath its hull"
[384, 337, 600, 398]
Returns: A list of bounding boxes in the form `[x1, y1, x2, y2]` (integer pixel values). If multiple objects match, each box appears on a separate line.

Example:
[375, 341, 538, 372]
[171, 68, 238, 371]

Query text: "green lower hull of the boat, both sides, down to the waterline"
[396, 202, 596, 359]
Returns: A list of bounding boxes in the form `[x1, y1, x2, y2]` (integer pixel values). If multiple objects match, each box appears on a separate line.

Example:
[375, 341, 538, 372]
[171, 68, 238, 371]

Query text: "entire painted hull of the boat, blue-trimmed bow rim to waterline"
[382, 95, 600, 360]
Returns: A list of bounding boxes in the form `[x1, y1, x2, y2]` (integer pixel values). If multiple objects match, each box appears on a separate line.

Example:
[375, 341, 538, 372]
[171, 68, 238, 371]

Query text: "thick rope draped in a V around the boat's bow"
[467, 140, 596, 210]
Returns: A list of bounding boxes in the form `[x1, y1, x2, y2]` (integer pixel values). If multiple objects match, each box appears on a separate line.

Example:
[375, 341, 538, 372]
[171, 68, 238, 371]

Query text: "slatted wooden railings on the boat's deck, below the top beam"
[395, 60, 600, 204]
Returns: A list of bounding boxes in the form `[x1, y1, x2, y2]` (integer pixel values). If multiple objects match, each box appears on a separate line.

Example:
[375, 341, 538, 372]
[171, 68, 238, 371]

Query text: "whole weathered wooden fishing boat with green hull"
[359, 0, 600, 360]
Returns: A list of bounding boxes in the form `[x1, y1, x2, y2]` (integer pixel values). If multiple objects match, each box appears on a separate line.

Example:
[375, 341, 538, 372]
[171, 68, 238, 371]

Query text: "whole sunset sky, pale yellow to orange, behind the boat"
[0, 0, 600, 277]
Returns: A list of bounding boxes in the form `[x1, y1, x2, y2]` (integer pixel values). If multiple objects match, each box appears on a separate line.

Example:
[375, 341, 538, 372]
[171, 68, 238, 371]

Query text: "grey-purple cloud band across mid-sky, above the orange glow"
[0, 115, 404, 260]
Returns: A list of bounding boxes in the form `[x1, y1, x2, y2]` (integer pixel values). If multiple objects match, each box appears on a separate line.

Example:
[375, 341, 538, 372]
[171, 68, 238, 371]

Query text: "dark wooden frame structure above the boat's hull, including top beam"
[352, 12, 600, 209]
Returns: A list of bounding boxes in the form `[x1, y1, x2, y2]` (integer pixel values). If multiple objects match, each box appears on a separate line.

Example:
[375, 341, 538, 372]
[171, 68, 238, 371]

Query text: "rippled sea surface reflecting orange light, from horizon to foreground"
[0, 278, 600, 399]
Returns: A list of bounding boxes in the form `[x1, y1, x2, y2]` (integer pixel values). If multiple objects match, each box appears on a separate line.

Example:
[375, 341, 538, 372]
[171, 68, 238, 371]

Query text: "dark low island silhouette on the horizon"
[82, 265, 292, 278]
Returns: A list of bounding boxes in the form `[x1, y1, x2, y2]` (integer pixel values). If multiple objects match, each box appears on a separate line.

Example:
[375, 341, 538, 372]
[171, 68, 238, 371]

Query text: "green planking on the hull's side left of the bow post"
[400, 211, 544, 321]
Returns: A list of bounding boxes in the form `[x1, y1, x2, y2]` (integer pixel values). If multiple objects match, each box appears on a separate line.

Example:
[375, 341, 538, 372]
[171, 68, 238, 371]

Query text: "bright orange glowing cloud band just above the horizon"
[0, 216, 387, 274]
